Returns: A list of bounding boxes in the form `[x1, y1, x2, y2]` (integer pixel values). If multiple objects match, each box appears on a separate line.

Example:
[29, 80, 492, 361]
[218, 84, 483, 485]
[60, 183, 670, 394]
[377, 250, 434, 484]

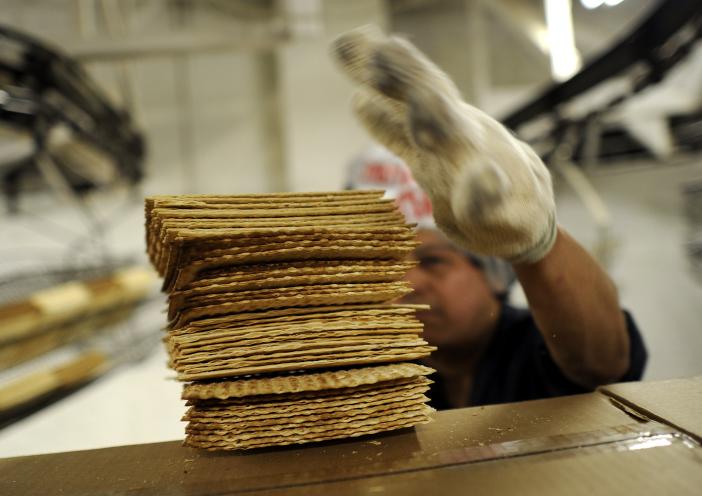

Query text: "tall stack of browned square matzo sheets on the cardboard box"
[146, 191, 433, 449]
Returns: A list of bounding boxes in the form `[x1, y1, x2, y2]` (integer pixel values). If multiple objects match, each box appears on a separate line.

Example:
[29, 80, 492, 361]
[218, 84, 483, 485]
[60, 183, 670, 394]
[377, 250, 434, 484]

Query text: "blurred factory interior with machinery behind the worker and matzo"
[0, 0, 702, 457]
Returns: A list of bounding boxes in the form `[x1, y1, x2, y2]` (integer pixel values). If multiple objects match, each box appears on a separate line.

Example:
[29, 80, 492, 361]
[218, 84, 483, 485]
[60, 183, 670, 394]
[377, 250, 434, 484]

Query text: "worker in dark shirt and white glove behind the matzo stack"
[333, 28, 647, 409]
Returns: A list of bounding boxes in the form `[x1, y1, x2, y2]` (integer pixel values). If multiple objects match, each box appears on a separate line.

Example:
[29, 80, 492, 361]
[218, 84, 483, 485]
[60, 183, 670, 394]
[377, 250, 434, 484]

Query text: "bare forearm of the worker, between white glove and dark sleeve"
[515, 229, 629, 387]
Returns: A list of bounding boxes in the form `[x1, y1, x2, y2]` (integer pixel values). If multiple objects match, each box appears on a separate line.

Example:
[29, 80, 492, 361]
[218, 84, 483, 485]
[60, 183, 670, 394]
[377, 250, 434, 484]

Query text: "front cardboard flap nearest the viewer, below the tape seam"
[266, 432, 702, 496]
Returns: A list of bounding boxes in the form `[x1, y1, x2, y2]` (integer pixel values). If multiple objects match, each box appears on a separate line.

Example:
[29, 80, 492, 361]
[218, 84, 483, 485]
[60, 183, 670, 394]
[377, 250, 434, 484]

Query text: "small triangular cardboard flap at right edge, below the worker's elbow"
[600, 376, 702, 441]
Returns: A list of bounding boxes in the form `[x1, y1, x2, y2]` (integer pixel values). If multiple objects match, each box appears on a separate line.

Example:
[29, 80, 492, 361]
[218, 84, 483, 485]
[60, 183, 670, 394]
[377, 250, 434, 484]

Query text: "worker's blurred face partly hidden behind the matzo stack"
[402, 230, 499, 347]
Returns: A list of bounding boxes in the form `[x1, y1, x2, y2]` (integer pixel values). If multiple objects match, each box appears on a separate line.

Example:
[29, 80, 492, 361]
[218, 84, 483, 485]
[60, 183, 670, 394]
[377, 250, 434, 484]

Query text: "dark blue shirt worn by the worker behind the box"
[429, 305, 647, 410]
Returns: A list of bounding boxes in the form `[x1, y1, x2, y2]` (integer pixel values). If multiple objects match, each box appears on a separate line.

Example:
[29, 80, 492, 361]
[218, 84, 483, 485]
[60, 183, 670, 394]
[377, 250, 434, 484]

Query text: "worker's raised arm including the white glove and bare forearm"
[333, 27, 629, 387]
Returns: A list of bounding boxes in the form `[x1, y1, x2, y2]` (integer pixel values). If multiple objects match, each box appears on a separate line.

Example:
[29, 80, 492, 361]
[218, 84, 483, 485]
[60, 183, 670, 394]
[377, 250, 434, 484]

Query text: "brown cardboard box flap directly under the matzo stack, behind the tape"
[0, 393, 648, 496]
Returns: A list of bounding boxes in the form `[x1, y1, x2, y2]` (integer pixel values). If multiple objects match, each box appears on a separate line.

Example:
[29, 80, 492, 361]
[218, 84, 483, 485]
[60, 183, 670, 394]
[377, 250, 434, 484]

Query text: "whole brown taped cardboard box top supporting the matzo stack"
[0, 377, 702, 496]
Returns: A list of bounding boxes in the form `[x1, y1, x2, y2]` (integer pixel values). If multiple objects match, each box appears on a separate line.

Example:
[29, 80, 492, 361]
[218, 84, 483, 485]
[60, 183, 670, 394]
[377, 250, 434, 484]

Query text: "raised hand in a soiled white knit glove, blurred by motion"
[332, 27, 556, 263]
